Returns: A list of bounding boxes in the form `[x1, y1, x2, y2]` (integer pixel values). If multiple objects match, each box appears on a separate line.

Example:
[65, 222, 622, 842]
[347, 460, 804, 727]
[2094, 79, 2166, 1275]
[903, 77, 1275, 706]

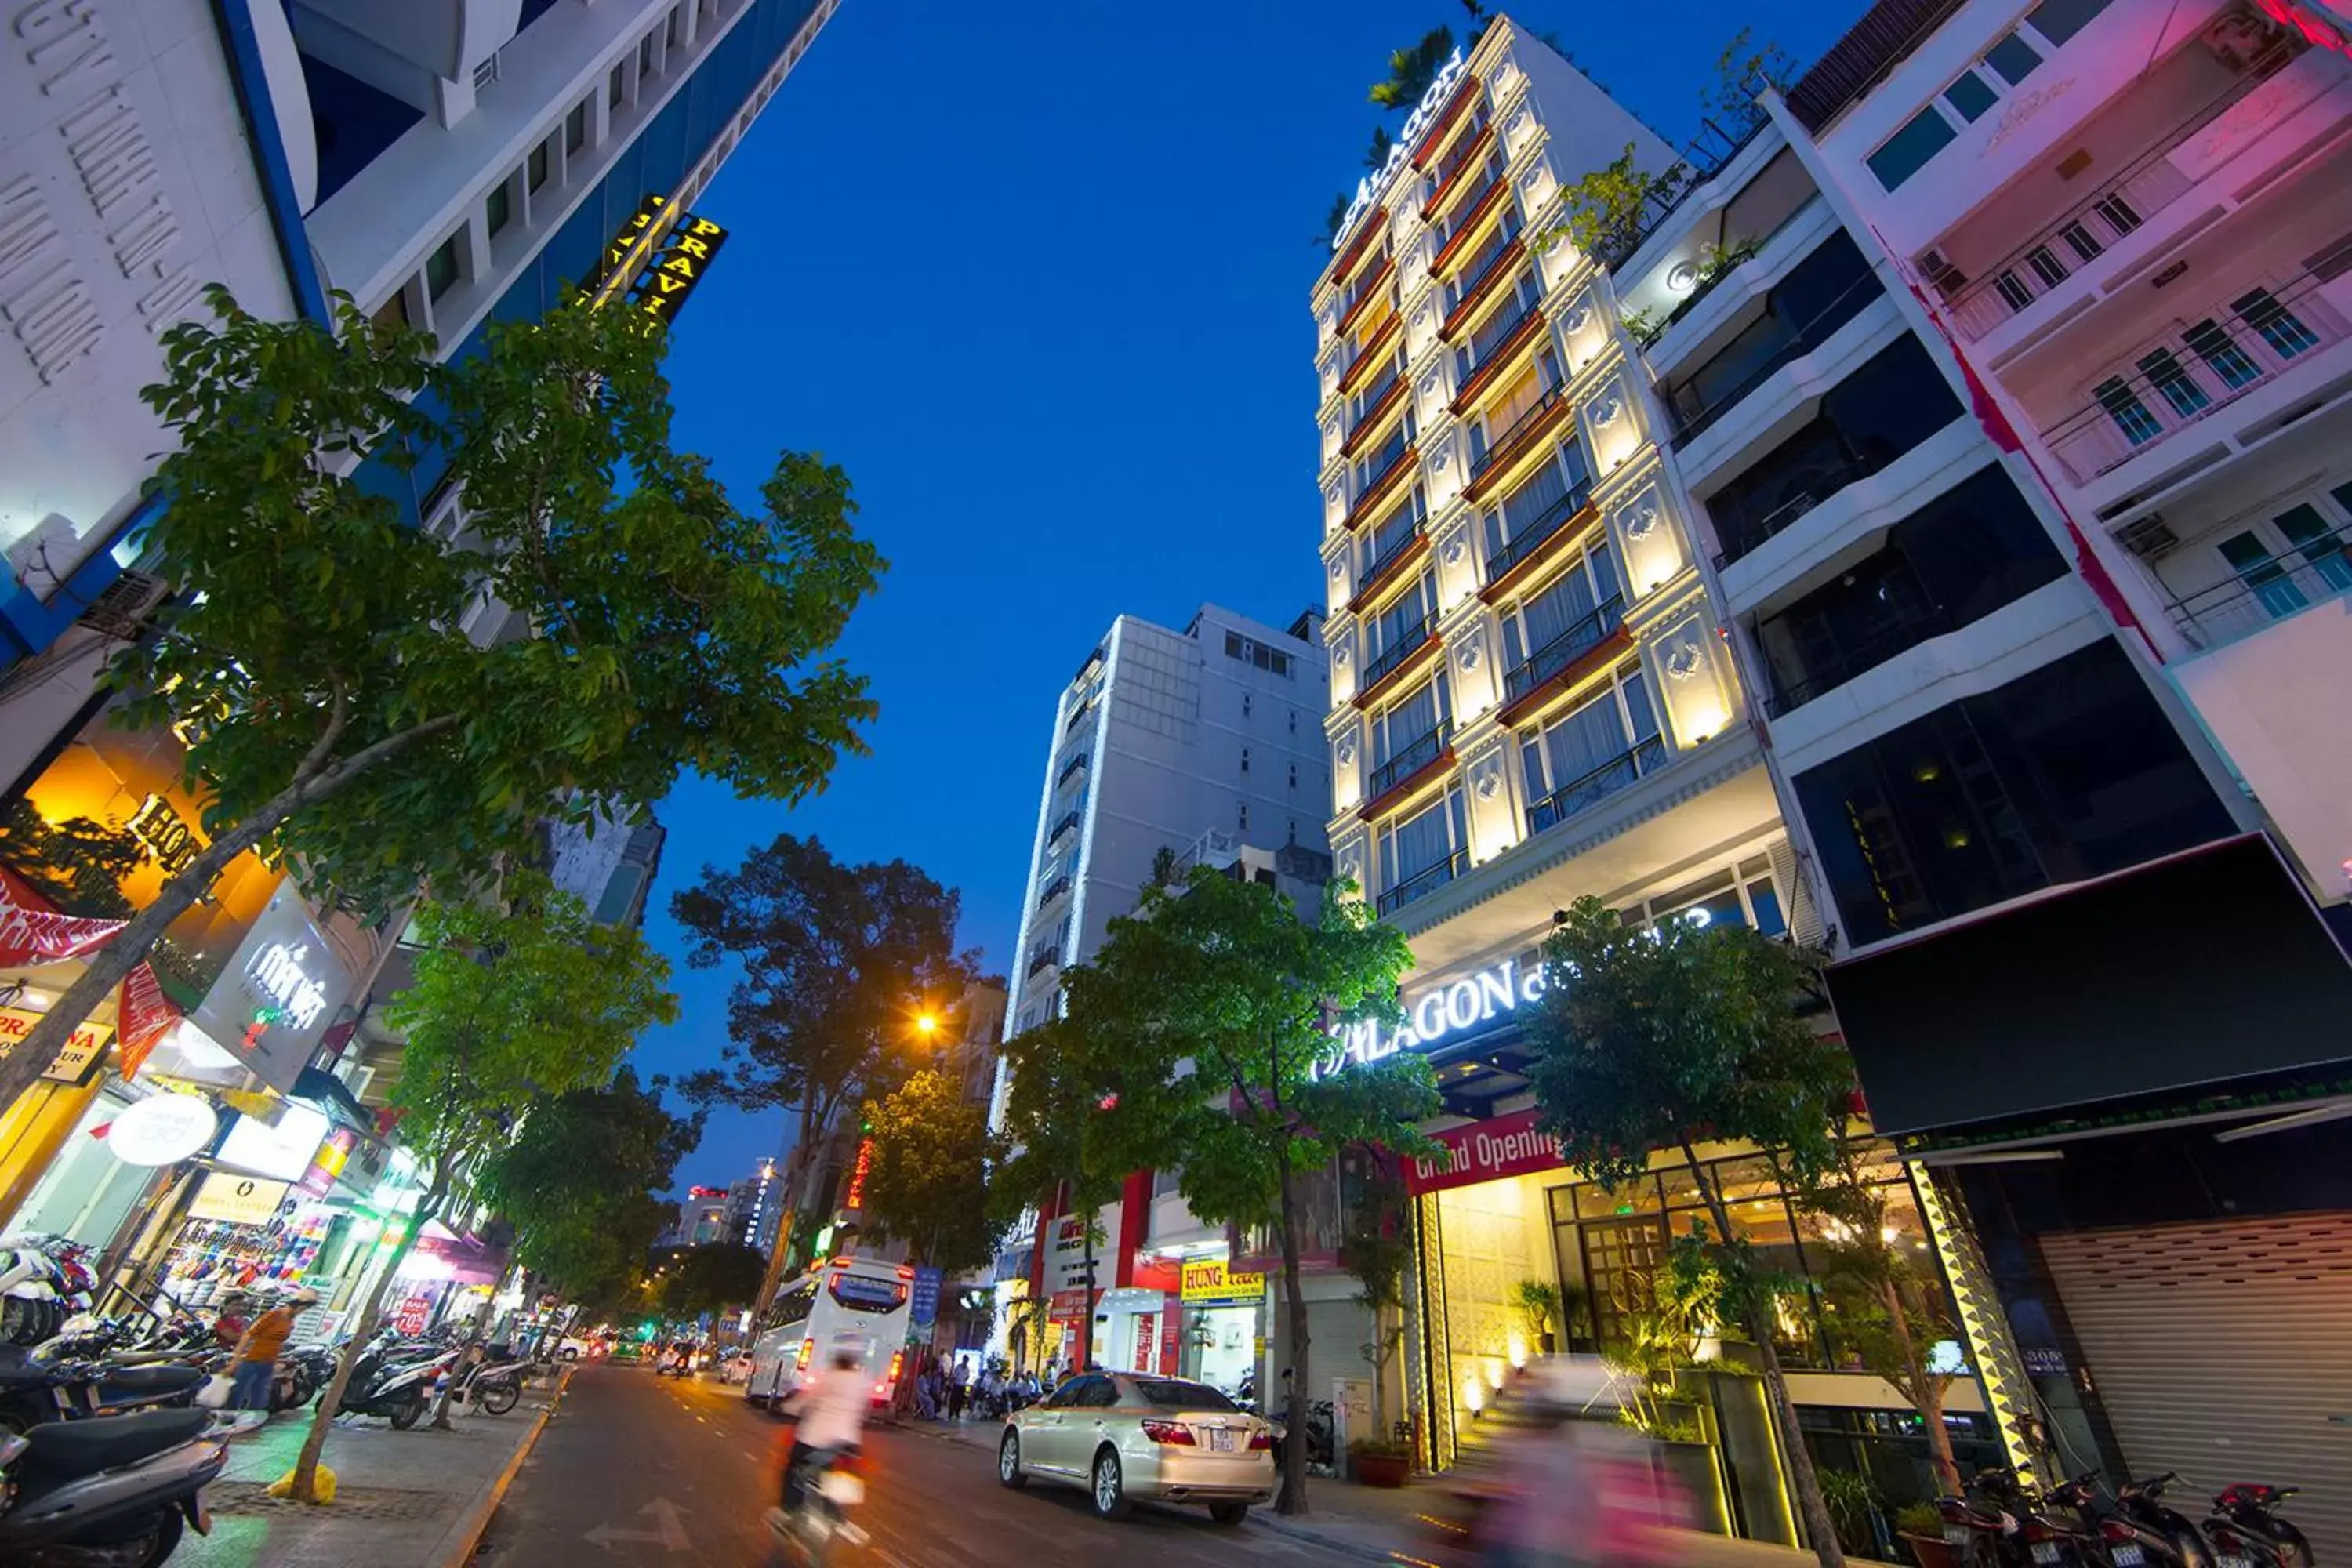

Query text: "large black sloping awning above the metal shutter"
[1828, 834, 2352, 1138]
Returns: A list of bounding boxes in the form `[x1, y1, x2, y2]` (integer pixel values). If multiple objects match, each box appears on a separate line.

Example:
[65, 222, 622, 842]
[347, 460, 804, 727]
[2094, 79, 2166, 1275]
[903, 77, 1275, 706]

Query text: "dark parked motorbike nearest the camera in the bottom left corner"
[0, 1410, 228, 1568]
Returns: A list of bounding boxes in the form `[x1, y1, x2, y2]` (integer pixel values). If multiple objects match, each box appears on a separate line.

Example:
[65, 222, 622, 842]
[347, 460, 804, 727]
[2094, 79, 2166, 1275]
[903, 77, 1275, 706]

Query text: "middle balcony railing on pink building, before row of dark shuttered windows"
[2042, 273, 2345, 485]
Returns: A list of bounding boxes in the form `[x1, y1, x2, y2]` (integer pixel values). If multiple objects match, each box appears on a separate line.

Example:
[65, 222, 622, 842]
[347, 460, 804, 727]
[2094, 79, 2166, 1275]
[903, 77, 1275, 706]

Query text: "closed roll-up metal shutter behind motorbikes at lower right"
[2042, 1213, 2352, 1563]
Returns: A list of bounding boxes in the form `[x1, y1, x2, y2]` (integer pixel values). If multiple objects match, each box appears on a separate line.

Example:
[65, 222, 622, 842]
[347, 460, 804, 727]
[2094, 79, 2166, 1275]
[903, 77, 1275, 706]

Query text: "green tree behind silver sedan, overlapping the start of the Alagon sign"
[1068, 865, 1437, 1514]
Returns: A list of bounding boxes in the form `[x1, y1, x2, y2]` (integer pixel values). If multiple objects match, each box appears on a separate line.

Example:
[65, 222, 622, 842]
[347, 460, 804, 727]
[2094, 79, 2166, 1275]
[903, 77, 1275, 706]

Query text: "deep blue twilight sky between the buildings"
[637, 0, 1863, 1185]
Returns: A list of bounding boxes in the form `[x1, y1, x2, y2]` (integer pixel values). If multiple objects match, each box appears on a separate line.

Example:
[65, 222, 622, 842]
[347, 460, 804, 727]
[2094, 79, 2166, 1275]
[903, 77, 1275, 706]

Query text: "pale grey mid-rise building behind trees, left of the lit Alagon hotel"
[995, 604, 1331, 1382]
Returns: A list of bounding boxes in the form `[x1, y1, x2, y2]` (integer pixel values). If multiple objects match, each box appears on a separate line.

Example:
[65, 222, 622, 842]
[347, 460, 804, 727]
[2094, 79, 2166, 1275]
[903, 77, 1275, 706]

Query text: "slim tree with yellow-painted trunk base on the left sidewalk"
[294, 872, 677, 1502]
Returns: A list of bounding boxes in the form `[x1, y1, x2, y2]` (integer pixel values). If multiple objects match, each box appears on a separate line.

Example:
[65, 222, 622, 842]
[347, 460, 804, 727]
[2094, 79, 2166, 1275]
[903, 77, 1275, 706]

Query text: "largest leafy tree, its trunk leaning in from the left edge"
[0, 289, 882, 1107]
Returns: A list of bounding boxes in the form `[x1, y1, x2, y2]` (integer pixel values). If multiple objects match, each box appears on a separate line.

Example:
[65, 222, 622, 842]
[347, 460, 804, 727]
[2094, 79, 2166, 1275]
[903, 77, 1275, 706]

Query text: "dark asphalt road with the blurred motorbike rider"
[473, 1366, 1362, 1568]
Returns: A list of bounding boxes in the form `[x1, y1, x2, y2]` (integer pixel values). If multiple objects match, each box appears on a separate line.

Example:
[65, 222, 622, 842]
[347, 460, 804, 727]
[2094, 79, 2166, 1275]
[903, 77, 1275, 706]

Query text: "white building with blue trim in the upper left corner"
[0, 0, 837, 799]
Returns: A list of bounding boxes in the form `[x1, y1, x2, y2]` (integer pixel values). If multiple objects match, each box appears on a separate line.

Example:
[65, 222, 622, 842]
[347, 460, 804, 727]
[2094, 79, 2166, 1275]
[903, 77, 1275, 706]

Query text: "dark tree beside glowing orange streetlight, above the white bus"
[670, 832, 978, 1300]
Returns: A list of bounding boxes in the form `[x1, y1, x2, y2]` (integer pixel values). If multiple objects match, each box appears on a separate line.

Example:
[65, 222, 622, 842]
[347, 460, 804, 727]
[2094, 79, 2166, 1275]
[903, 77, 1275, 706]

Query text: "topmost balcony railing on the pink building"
[1931, 42, 2328, 339]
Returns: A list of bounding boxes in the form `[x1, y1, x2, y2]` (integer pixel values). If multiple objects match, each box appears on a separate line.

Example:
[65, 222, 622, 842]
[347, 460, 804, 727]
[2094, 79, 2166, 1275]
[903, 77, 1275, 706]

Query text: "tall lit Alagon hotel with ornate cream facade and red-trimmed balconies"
[1310, 19, 1891, 1504]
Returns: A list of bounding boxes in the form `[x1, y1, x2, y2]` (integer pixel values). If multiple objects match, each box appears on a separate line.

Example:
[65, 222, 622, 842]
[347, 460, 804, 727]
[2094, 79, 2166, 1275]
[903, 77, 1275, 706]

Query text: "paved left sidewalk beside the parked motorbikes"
[172, 1373, 569, 1568]
